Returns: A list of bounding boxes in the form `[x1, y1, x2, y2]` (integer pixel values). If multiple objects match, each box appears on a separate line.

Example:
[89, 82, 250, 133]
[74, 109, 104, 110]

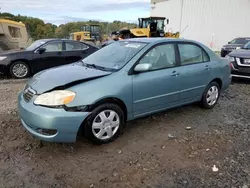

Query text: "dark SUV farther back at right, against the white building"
[221, 37, 250, 57]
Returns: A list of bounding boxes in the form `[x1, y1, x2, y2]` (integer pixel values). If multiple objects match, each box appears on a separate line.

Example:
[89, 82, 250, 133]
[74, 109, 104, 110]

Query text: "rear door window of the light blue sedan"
[178, 44, 209, 65]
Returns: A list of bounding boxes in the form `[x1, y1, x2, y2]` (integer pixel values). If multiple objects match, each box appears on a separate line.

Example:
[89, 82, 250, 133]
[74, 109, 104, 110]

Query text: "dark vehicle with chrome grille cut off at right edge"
[227, 42, 250, 79]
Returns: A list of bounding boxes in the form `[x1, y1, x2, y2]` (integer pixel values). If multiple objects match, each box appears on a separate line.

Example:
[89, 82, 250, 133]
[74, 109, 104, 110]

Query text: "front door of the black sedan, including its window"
[32, 41, 65, 73]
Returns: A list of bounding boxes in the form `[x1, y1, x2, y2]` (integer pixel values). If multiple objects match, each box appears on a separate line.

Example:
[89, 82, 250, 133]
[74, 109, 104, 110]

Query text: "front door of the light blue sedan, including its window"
[133, 44, 179, 117]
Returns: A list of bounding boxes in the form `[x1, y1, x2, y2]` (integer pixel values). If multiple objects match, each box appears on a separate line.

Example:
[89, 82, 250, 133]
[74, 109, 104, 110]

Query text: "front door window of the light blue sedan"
[139, 44, 176, 70]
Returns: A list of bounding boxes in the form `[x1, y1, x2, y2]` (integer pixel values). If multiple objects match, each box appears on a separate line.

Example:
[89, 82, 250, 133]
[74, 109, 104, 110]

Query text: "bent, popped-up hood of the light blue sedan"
[27, 63, 112, 94]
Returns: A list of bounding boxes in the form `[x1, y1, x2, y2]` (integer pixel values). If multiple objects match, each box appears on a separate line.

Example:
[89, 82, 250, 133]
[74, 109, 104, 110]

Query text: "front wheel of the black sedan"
[10, 61, 30, 79]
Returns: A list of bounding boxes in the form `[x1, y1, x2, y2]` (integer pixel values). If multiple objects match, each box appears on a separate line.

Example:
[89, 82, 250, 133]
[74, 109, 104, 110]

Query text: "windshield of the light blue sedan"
[83, 41, 147, 70]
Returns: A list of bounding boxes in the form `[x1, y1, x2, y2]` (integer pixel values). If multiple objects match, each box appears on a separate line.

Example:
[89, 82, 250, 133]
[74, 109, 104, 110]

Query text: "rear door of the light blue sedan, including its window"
[177, 43, 213, 103]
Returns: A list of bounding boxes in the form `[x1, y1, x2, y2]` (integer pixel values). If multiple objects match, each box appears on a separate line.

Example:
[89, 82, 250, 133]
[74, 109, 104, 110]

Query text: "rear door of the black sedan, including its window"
[63, 41, 91, 64]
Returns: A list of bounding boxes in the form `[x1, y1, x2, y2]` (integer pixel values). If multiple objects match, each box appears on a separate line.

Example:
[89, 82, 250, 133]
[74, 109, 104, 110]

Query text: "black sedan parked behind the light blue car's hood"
[0, 39, 99, 78]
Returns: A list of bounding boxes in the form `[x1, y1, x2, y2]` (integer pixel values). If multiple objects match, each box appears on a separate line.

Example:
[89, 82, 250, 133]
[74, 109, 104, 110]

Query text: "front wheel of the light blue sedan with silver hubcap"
[84, 103, 125, 144]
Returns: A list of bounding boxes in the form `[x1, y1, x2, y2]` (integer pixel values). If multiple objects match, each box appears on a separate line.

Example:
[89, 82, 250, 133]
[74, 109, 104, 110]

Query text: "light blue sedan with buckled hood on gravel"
[18, 38, 231, 144]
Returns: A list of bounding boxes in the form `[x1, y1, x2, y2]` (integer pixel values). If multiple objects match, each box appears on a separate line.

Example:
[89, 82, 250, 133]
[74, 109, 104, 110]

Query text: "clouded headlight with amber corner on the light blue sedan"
[34, 90, 76, 107]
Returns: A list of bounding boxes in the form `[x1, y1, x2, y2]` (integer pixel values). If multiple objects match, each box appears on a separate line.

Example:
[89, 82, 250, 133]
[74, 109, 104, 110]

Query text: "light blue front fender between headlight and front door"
[67, 71, 133, 114]
